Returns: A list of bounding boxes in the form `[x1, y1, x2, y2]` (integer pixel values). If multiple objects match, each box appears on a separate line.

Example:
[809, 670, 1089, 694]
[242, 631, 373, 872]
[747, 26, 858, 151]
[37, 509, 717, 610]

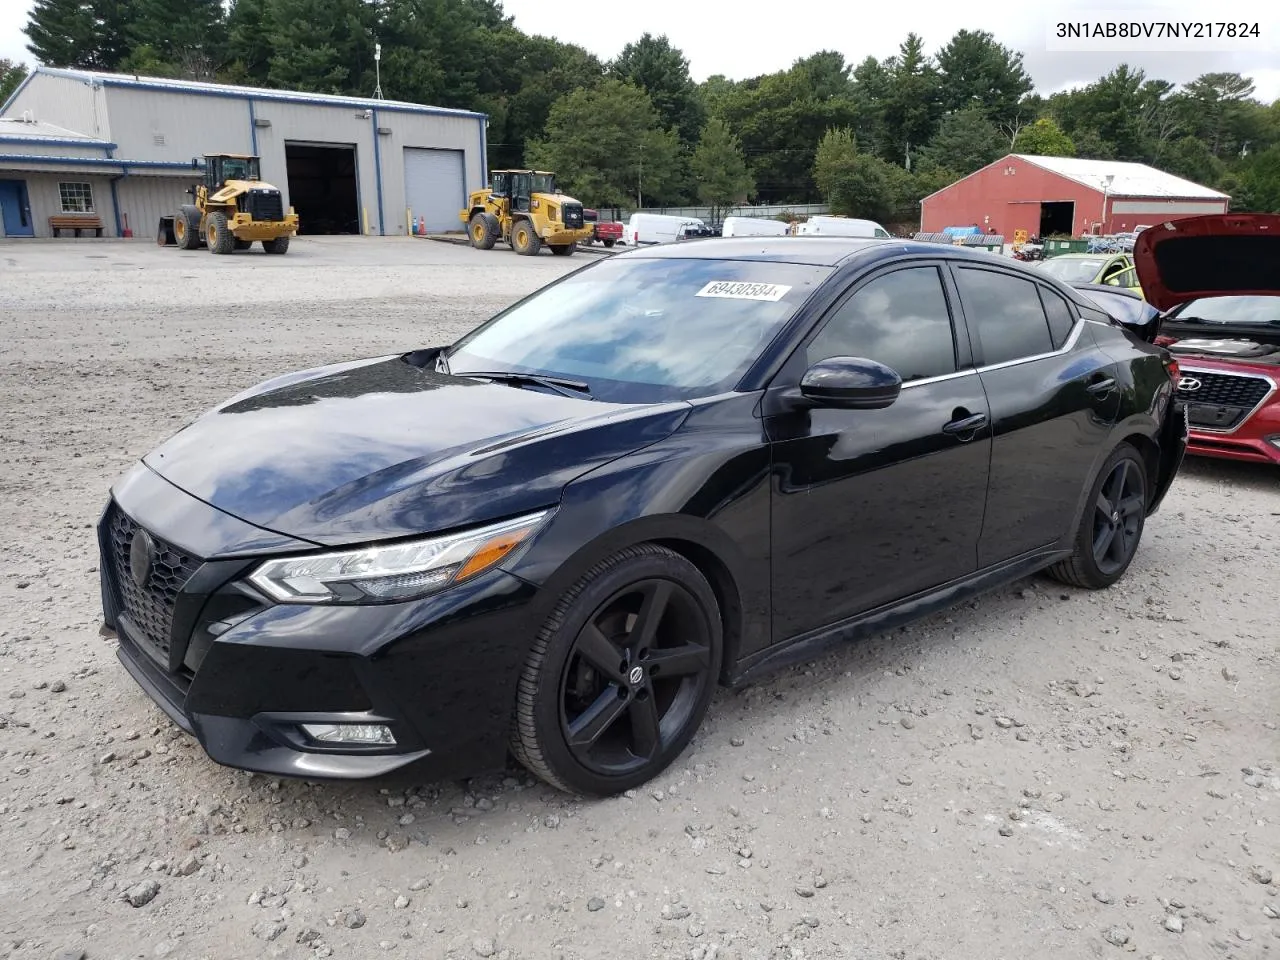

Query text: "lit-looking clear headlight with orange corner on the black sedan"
[250, 509, 552, 603]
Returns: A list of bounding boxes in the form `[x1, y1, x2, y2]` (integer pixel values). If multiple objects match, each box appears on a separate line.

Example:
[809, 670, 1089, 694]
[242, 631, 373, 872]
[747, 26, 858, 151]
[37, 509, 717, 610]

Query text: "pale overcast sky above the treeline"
[0, 0, 1280, 102]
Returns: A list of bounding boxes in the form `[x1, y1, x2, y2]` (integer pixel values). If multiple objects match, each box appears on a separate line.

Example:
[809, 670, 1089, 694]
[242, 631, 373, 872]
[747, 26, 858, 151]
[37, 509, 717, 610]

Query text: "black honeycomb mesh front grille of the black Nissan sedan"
[108, 503, 200, 663]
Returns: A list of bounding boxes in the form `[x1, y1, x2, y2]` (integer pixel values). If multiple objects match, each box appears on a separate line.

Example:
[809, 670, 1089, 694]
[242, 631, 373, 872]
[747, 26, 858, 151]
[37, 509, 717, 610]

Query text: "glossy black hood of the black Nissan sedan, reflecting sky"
[143, 356, 689, 545]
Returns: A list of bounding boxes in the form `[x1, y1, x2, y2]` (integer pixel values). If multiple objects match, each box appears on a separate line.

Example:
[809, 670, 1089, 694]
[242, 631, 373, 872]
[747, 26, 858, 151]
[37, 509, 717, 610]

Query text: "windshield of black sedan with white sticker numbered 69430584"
[445, 257, 831, 403]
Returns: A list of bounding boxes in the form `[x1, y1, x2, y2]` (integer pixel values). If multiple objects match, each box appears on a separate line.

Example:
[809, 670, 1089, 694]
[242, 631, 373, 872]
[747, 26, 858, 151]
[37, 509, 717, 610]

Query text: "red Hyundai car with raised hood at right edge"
[1133, 214, 1280, 465]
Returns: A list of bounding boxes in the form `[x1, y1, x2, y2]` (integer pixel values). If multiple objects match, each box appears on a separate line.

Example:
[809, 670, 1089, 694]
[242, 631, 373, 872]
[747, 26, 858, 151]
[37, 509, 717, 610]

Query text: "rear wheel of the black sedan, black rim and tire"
[1047, 443, 1149, 590]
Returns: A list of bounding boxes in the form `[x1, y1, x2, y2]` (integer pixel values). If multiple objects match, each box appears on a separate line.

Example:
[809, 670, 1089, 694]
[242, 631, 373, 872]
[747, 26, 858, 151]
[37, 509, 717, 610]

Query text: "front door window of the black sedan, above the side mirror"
[805, 266, 956, 383]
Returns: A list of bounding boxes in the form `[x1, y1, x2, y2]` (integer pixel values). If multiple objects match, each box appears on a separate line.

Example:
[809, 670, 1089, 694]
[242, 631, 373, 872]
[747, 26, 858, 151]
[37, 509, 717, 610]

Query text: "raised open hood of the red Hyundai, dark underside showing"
[1133, 214, 1280, 311]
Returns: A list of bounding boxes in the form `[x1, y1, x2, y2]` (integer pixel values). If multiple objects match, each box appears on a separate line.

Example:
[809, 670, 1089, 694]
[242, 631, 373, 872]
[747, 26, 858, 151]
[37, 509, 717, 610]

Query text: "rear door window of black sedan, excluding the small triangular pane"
[956, 268, 1053, 365]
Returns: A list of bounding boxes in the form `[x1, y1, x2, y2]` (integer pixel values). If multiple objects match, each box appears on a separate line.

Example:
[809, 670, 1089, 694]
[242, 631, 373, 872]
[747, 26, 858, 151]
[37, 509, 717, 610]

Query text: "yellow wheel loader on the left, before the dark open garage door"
[156, 154, 298, 253]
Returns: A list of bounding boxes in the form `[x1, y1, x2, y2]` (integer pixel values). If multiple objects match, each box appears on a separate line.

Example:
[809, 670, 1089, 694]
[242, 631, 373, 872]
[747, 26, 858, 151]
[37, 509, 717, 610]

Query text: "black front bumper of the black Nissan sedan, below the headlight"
[99, 466, 534, 780]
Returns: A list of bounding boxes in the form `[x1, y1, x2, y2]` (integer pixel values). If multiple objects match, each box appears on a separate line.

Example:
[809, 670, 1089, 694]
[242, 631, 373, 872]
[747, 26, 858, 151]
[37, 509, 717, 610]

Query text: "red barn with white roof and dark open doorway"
[920, 154, 1230, 239]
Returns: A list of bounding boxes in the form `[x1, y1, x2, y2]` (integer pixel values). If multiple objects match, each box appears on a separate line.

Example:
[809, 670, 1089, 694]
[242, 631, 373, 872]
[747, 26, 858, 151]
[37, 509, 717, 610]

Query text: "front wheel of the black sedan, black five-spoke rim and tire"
[511, 544, 723, 796]
